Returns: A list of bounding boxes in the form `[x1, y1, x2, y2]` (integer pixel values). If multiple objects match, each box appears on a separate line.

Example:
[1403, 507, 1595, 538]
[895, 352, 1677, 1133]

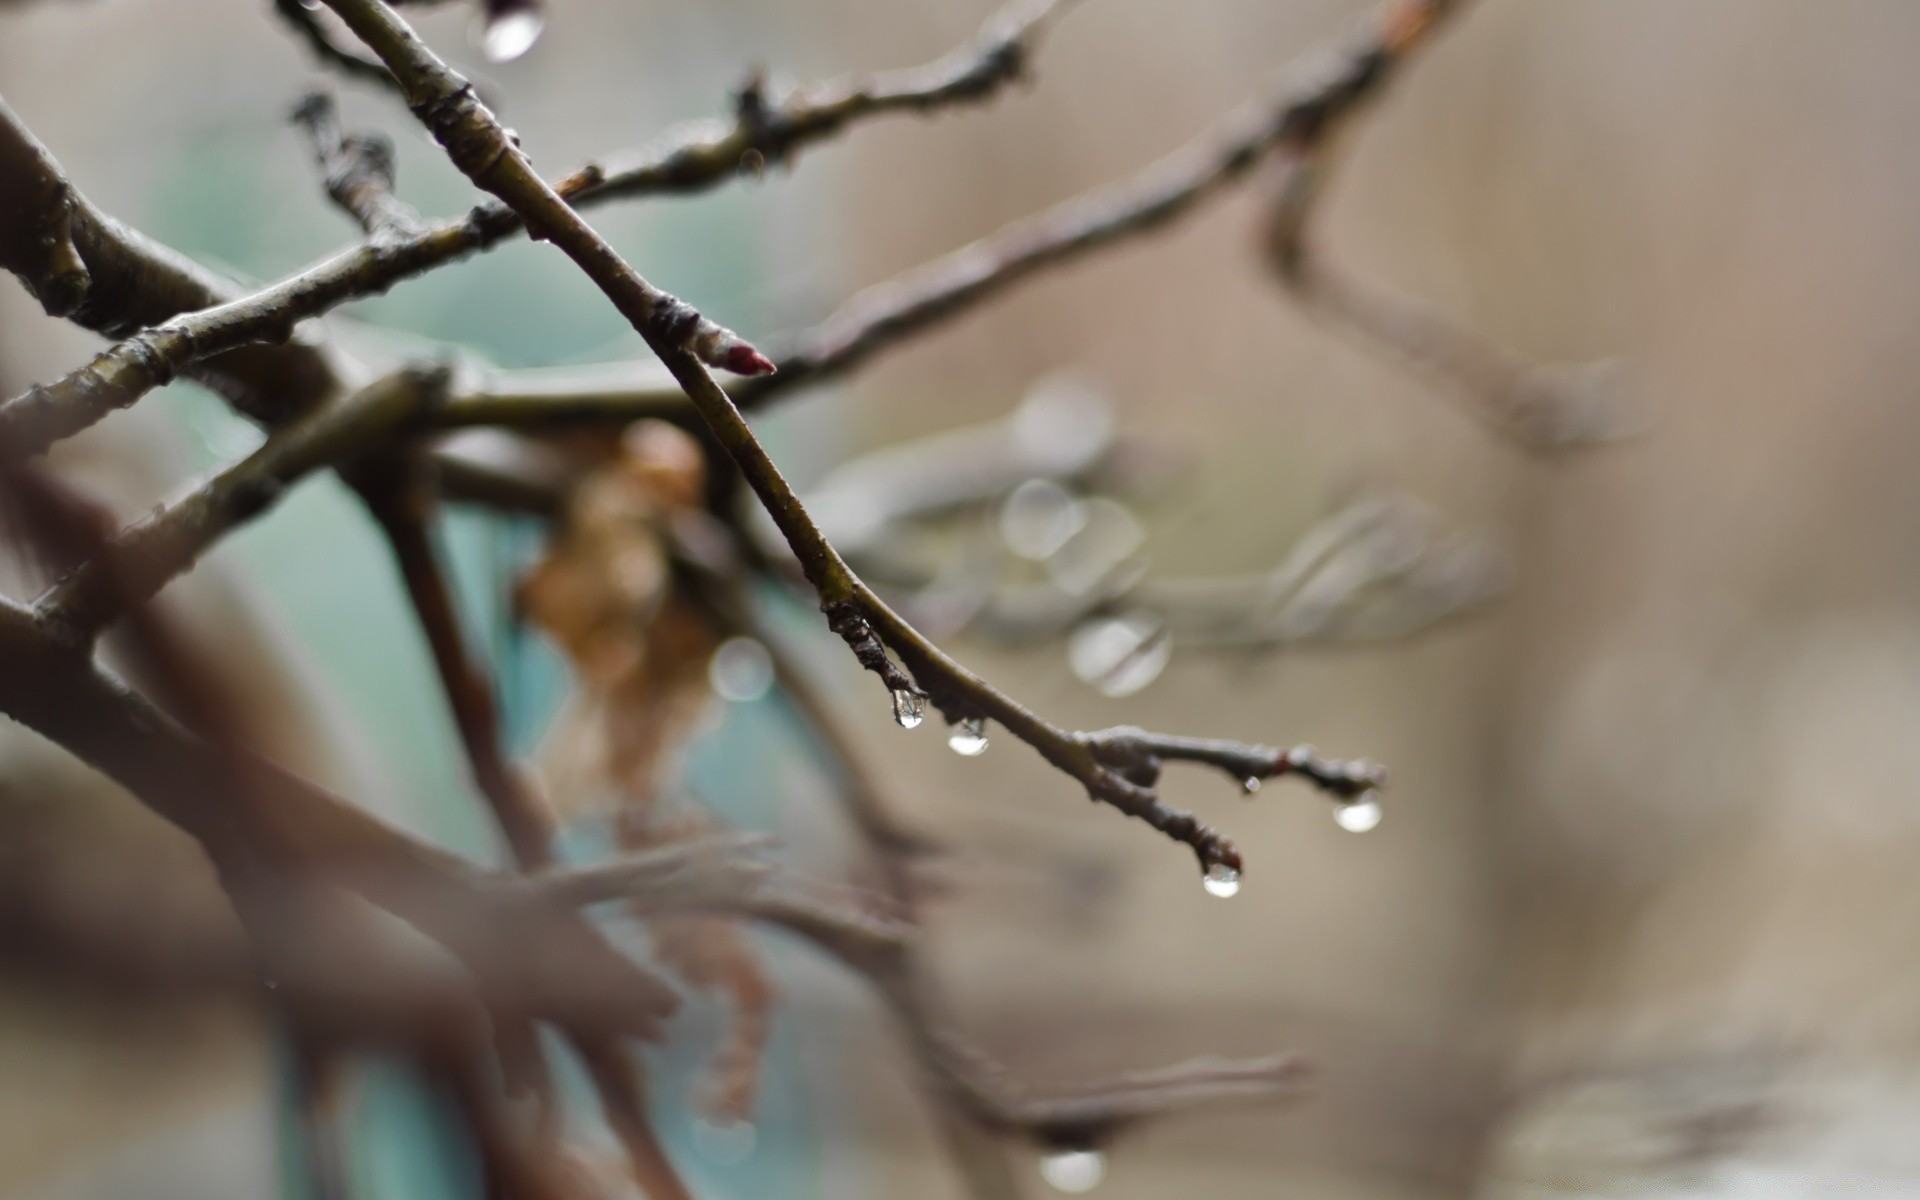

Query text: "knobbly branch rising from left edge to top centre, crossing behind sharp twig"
[0, 0, 1058, 455]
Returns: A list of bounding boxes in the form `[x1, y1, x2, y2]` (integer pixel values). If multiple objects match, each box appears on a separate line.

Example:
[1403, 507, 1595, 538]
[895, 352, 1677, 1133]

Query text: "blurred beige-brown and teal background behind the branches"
[0, 0, 1920, 1200]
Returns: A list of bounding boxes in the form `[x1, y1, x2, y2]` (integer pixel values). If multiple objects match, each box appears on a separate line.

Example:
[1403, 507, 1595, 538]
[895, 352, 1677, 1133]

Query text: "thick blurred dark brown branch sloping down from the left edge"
[0, 449, 674, 1037]
